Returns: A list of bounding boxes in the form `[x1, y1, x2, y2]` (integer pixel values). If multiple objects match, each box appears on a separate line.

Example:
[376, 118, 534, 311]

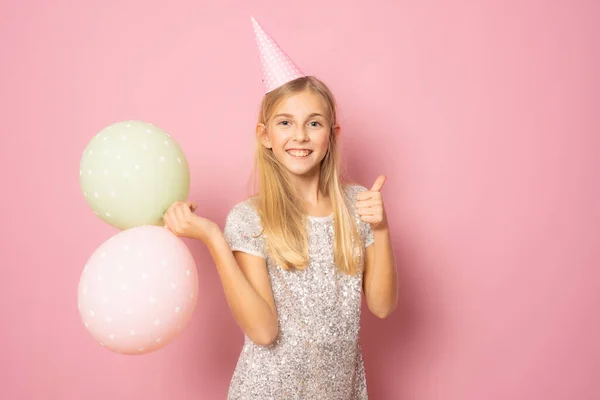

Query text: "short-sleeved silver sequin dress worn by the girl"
[224, 185, 374, 400]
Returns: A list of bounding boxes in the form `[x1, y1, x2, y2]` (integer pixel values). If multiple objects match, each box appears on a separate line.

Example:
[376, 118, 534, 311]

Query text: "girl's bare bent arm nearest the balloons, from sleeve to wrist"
[207, 231, 278, 346]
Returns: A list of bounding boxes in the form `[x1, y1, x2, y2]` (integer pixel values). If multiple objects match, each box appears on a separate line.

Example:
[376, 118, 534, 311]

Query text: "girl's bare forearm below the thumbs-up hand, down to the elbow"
[363, 228, 398, 318]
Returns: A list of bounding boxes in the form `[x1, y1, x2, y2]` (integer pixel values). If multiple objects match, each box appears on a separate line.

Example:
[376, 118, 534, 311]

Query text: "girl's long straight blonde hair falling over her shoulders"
[255, 76, 364, 274]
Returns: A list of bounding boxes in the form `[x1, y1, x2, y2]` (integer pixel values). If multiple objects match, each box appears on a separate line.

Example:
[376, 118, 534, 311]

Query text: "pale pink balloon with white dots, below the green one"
[78, 226, 198, 354]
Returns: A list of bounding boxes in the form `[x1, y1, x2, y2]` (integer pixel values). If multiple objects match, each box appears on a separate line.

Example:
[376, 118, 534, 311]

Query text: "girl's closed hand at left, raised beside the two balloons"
[163, 201, 221, 245]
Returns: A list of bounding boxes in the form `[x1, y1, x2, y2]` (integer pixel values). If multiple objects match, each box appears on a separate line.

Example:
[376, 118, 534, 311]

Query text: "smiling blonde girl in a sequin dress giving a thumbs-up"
[165, 17, 397, 400]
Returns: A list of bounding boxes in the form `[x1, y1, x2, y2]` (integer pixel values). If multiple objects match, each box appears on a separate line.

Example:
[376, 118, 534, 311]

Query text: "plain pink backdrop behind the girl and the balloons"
[0, 0, 600, 400]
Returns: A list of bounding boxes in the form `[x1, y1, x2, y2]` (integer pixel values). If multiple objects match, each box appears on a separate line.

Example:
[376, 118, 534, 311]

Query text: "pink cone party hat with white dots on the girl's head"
[251, 17, 305, 93]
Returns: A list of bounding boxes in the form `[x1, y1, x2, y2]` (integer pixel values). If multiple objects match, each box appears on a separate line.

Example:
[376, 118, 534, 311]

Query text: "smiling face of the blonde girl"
[259, 91, 330, 180]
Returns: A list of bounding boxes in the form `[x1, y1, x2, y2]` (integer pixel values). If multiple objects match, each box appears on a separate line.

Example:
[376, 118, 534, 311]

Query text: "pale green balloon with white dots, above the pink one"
[79, 121, 190, 230]
